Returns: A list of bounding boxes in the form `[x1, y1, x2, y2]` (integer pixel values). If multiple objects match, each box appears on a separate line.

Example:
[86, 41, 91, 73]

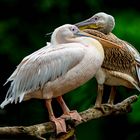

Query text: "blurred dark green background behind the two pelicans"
[0, 0, 140, 140]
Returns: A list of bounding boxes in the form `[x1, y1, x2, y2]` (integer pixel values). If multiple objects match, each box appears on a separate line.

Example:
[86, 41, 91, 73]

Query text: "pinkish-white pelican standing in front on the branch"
[0, 24, 104, 133]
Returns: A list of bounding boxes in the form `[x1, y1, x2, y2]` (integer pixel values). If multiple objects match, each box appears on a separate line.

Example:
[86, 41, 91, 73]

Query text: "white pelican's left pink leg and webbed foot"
[45, 99, 66, 134]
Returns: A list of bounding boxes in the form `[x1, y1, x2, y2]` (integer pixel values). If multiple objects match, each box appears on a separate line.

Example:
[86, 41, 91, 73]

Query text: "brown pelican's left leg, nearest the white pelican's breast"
[95, 84, 104, 109]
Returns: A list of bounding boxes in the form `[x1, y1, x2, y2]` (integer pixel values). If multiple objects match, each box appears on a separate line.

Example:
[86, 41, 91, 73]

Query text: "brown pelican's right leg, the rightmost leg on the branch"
[108, 86, 116, 105]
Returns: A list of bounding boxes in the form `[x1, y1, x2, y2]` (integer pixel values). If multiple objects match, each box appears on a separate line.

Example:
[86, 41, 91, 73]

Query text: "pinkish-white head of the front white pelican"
[51, 24, 89, 45]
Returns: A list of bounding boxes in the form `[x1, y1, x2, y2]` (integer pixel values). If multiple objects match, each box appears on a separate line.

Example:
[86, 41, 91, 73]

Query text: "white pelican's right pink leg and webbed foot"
[57, 96, 82, 121]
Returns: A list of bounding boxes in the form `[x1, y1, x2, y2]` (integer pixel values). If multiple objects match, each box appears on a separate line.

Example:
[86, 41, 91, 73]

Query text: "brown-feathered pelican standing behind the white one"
[75, 12, 140, 107]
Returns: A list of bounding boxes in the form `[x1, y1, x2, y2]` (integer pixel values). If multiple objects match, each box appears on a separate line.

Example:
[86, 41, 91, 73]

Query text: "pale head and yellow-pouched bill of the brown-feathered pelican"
[75, 12, 115, 34]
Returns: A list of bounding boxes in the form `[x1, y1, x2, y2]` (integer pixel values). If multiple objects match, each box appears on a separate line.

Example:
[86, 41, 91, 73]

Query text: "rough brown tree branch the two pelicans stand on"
[0, 95, 138, 140]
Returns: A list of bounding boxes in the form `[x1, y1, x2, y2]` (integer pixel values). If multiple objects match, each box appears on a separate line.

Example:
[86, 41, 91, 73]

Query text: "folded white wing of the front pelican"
[1, 43, 85, 107]
